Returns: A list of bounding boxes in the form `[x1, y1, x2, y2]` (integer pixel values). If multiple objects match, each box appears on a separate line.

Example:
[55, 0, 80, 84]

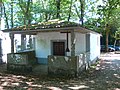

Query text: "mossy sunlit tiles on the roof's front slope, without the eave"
[11, 20, 79, 31]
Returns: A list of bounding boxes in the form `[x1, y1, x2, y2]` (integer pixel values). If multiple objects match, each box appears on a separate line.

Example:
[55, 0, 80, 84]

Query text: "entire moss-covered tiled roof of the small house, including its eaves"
[2, 20, 100, 34]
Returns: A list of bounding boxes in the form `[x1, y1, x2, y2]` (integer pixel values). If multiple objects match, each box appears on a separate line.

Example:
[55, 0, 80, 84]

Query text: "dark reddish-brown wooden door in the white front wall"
[53, 42, 65, 56]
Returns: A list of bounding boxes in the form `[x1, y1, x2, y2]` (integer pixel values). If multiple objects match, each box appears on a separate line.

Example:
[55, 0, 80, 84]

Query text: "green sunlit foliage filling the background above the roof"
[3, 0, 120, 33]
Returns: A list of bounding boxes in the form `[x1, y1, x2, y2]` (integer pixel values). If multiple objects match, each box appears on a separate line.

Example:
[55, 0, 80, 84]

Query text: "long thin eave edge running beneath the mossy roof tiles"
[2, 26, 98, 35]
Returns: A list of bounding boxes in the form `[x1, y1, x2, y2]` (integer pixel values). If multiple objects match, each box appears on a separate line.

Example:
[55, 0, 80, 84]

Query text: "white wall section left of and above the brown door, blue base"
[36, 32, 66, 64]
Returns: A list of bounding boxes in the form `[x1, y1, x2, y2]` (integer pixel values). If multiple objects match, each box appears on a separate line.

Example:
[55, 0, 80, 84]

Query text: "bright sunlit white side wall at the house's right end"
[90, 33, 100, 61]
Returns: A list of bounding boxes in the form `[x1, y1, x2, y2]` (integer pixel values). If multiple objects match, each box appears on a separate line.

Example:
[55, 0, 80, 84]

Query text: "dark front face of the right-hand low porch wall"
[48, 56, 78, 75]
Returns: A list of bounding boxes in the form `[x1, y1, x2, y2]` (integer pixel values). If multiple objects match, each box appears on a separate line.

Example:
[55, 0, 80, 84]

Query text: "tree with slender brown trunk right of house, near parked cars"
[99, 0, 120, 51]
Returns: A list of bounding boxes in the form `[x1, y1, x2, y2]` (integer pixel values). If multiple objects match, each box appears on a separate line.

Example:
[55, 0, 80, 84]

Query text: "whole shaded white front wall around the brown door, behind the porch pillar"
[35, 32, 86, 64]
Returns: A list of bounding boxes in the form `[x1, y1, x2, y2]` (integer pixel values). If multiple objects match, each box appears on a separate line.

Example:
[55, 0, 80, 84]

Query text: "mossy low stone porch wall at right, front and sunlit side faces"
[48, 53, 90, 76]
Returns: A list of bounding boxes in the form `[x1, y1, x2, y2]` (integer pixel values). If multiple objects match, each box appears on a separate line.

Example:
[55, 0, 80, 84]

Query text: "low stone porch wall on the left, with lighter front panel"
[7, 51, 37, 72]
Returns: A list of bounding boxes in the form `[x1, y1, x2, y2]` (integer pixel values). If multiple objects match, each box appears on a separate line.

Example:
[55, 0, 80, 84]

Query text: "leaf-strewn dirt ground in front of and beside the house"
[0, 53, 120, 90]
